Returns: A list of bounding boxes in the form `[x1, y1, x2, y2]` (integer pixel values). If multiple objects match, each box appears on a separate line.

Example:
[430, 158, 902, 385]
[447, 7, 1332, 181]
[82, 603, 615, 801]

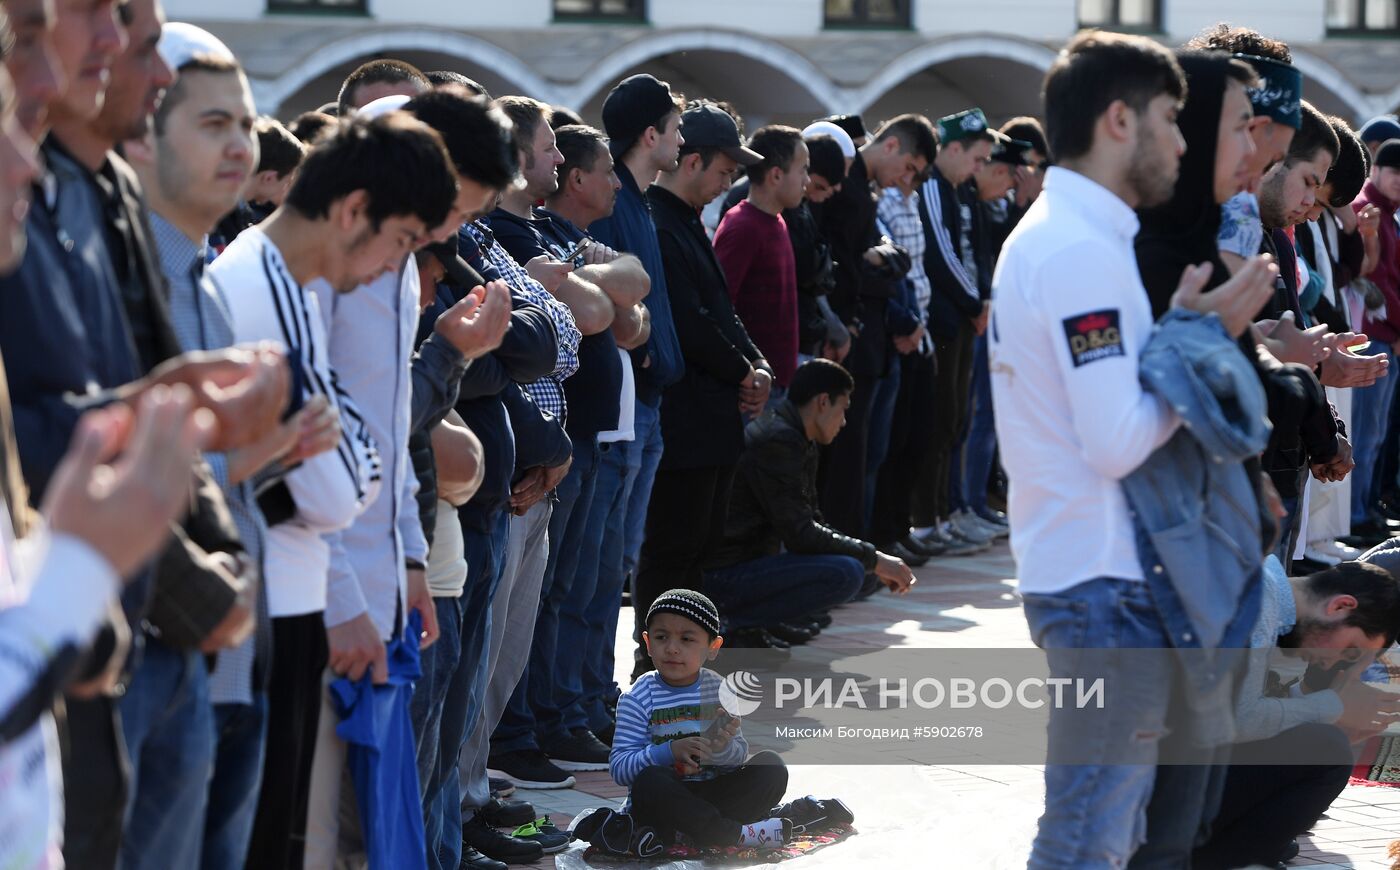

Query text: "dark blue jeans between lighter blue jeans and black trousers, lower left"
[199, 692, 267, 870]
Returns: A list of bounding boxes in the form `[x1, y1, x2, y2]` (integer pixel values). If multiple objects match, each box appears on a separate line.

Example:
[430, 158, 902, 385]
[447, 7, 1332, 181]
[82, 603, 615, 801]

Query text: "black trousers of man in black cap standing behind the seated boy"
[631, 465, 736, 677]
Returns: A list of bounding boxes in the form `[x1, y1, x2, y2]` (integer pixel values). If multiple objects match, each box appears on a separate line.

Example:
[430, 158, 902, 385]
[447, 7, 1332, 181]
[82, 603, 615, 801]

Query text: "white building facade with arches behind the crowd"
[165, 0, 1400, 129]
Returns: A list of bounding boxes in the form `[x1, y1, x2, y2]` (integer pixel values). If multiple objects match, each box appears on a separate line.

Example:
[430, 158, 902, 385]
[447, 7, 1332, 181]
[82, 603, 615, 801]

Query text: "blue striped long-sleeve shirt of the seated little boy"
[608, 670, 749, 786]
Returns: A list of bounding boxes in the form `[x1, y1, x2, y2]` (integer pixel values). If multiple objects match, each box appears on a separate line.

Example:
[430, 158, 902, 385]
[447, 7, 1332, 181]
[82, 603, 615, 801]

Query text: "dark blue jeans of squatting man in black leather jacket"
[704, 553, 865, 629]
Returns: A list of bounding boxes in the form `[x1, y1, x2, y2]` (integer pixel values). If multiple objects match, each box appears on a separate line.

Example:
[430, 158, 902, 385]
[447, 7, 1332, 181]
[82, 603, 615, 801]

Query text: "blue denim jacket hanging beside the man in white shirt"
[1123, 310, 1270, 741]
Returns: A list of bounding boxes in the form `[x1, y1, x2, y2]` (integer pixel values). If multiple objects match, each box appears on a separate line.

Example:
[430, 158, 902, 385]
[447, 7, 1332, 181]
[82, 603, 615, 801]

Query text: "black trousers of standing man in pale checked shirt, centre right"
[869, 353, 938, 543]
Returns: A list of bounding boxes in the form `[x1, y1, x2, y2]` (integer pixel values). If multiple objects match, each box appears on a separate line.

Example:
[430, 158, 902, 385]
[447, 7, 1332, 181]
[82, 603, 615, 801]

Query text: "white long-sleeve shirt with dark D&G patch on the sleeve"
[987, 167, 1179, 594]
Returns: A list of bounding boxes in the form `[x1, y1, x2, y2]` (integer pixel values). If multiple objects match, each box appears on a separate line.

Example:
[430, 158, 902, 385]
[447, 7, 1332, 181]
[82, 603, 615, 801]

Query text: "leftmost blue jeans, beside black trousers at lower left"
[118, 637, 214, 870]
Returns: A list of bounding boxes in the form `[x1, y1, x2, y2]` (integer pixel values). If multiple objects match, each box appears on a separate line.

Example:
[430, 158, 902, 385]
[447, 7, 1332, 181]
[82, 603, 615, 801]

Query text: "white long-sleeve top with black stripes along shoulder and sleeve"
[209, 227, 379, 616]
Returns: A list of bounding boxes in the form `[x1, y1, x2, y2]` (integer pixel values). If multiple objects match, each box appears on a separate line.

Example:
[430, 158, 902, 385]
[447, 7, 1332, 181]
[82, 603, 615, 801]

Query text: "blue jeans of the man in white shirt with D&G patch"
[1025, 577, 1207, 870]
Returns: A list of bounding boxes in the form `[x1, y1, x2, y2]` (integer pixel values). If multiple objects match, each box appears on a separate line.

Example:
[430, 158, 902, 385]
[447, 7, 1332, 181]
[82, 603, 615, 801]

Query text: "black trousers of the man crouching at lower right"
[1191, 723, 1352, 870]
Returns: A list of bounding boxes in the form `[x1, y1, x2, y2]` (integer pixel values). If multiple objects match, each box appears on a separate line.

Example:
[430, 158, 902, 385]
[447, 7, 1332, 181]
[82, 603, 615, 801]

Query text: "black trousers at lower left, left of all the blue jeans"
[60, 698, 130, 870]
